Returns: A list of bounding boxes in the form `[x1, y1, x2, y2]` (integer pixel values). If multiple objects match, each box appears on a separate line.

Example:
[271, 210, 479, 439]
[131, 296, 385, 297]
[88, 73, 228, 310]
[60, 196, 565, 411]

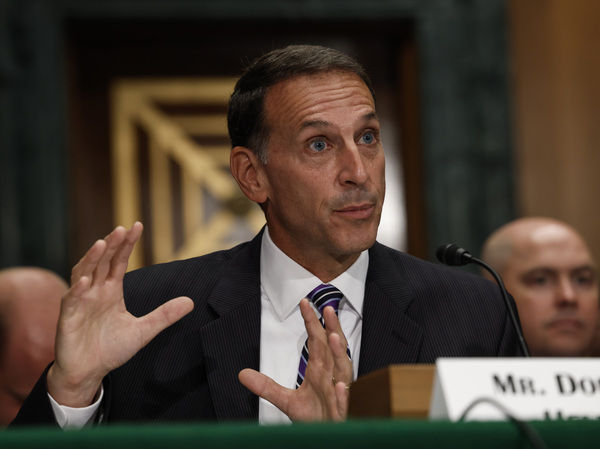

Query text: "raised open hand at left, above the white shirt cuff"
[47, 222, 194, 407]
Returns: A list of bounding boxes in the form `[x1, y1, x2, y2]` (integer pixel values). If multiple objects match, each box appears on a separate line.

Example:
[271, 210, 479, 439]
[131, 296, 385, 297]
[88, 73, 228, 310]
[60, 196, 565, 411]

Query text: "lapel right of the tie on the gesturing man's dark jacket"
[358, 243, 423, 376]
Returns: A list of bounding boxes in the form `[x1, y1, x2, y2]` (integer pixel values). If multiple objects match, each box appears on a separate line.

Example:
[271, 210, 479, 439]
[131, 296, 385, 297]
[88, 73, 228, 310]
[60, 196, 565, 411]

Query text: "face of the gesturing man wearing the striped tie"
[261, 72, 385, 274]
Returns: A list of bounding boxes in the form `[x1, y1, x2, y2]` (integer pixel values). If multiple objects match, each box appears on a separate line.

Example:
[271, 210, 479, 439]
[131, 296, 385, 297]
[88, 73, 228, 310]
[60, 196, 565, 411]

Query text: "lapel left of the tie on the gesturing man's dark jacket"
[200, 232, 262, 420]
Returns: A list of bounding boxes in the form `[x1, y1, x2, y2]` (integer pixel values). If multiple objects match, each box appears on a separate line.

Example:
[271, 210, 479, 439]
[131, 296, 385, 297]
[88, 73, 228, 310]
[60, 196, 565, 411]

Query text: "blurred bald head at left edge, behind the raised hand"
[0, 267, 68, 427]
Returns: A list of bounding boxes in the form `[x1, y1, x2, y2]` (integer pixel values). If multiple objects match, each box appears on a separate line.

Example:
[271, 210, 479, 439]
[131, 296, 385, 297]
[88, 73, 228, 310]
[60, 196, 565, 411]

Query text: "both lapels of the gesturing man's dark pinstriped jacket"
[200, 238, 423, 420]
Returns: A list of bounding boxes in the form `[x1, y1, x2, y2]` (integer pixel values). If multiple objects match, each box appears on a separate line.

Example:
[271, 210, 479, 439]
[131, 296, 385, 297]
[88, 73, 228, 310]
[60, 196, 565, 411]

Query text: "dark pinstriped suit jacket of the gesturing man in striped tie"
[13, 233, 520, 425]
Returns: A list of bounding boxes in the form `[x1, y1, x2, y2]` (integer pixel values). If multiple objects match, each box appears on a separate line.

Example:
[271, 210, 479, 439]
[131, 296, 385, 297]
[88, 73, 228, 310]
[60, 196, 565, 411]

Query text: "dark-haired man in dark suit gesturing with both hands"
[15, 46, 519, 426]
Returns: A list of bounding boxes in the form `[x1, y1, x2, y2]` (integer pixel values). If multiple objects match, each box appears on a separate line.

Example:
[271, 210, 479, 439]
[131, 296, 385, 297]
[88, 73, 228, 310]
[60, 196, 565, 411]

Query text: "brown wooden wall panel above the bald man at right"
[508, 0, 600, 261]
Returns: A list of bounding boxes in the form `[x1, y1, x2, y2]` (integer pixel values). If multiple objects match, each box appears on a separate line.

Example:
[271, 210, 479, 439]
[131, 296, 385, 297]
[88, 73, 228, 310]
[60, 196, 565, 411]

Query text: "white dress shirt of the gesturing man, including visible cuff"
[48, 229, 369, 428]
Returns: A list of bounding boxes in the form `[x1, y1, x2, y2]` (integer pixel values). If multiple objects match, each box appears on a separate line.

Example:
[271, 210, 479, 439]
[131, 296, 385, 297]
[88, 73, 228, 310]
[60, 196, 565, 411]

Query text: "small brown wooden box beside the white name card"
[348, 365, 435, 419]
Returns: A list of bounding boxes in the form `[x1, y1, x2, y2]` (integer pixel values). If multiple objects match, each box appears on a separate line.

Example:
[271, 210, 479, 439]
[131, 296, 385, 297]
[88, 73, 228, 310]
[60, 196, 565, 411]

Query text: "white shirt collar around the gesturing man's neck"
[260, 227, 369, 321]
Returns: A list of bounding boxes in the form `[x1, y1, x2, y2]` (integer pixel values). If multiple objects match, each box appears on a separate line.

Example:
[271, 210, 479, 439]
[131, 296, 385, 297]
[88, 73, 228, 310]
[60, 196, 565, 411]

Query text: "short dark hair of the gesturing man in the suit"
[227, 45, 374, 164]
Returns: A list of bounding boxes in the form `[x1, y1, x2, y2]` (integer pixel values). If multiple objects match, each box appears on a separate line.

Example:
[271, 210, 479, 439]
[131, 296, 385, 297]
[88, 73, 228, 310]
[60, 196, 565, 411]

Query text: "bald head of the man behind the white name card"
[481, 217, 599, 357]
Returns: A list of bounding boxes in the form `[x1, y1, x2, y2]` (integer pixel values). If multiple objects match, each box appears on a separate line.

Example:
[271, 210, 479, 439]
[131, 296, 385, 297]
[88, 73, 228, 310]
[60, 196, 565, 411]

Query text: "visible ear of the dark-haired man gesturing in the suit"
[229, 147, 268, 204]
